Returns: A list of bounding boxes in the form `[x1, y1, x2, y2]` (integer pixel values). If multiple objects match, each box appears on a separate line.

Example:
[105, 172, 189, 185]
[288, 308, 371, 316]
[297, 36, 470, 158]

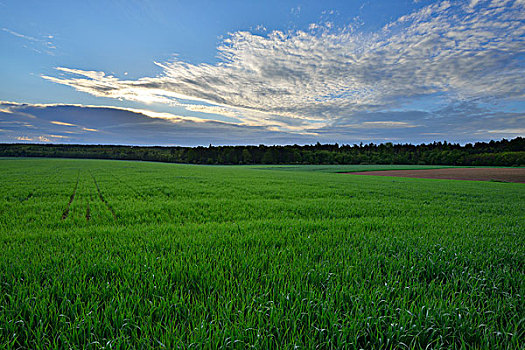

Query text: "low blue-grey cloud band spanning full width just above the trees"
[0, 101, 525, 146]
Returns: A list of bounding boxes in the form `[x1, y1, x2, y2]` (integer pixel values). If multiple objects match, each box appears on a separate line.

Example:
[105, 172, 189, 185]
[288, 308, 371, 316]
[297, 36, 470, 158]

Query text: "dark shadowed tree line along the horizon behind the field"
[0, 137, 525, 166]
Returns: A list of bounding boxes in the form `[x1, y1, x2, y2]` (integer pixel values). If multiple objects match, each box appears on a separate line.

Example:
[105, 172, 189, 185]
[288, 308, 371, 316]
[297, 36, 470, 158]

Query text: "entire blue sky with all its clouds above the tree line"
[0, 0, 525, 146]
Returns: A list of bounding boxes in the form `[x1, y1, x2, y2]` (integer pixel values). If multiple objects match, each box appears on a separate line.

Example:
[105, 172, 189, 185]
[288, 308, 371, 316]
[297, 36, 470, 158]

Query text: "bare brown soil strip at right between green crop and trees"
[345, 168, 525, 183]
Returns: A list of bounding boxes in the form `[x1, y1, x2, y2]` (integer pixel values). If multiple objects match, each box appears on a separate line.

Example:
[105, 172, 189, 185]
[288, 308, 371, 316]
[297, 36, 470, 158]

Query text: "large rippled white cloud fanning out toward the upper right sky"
[44, 0, 525, 130]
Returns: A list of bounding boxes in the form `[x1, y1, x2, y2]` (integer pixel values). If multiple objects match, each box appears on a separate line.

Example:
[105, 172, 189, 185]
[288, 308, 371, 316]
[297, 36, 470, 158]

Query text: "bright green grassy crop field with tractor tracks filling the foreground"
[0, 159, 525, 349]
